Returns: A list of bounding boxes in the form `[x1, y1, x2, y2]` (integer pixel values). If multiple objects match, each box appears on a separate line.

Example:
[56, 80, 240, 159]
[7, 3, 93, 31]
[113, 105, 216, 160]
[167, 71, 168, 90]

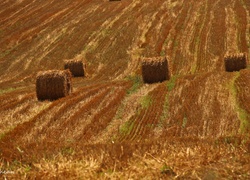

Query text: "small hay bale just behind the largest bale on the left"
[64, 59, 86, 77]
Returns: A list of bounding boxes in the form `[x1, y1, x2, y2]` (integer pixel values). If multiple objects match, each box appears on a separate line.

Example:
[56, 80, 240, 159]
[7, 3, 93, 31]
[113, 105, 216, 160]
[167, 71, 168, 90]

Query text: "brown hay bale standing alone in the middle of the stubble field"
[142, 57, 170, 83]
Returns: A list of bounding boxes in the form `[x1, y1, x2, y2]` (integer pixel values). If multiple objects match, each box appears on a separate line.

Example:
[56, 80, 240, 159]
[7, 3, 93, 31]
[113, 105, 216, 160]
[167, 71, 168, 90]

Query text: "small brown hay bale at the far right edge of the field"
[224, 53, 247, 72]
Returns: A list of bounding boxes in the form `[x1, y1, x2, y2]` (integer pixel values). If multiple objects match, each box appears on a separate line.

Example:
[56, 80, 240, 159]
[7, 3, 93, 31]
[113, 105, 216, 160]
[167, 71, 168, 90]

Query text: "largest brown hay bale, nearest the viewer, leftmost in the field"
[36, 70, 72, 101]
